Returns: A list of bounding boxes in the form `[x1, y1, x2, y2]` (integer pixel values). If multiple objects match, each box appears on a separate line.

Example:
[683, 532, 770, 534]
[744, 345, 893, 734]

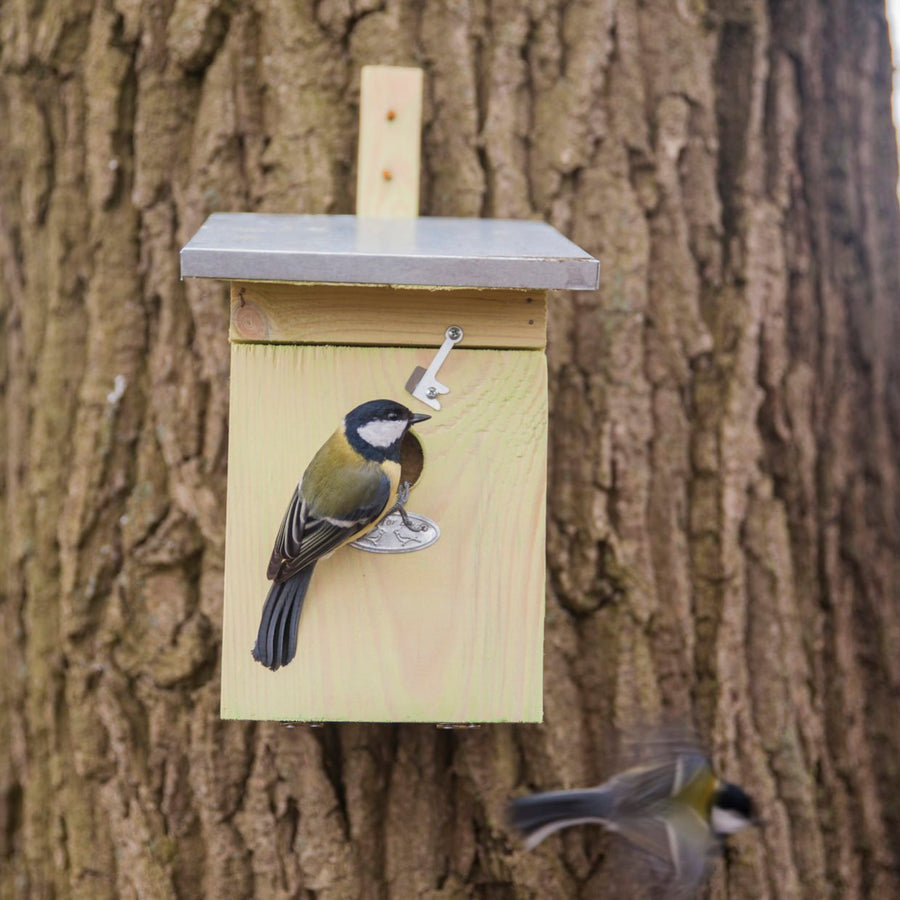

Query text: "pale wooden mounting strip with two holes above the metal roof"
[356, 66, 423, 219]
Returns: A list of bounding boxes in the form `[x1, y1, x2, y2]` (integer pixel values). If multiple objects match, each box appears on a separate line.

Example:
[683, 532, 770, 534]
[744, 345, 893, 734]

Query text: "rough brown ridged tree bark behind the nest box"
[0, 0, 900, 900]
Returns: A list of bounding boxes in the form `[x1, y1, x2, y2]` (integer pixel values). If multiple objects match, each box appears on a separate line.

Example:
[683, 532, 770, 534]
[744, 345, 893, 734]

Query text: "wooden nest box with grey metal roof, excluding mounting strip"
[181, 213, 599, 723]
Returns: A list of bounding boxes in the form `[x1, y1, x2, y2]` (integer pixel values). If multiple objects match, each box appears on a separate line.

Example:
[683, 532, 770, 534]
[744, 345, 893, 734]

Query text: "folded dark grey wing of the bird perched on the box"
[266, 473, 391, 581]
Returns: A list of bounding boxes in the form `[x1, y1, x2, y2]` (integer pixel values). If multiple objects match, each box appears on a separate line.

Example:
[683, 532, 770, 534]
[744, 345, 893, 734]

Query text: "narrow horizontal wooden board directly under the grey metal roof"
[230, 281, 547, 349]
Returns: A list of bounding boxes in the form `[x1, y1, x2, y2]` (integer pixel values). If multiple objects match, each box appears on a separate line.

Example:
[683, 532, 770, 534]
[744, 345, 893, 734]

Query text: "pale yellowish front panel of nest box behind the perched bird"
[222, 344, 547, 722]
